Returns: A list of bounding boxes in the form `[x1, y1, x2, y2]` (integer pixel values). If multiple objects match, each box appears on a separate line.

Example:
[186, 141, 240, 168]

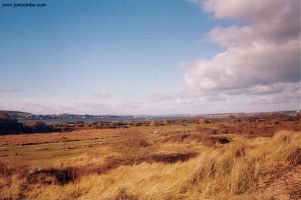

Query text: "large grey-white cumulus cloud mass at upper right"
[185, 0, 301, 102]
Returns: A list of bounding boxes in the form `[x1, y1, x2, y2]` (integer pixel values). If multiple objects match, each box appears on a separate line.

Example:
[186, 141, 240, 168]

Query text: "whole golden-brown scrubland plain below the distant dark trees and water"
[0, 117, 301, 200]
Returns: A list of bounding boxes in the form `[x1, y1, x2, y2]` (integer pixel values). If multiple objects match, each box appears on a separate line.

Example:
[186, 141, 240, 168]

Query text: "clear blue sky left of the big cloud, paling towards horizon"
[0, 0, 296, 114]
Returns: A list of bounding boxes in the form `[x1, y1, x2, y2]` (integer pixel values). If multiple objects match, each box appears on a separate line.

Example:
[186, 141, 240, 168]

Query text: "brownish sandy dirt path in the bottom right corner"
[262, 166, 301, 200]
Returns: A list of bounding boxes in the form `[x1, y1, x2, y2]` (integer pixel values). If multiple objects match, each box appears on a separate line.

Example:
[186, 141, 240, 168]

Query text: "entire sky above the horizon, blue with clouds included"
[0, 0, 301, 115]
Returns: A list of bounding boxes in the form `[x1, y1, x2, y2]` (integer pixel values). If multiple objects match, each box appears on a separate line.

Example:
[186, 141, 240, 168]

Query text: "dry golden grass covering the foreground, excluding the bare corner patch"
[0, 127, 301, 200]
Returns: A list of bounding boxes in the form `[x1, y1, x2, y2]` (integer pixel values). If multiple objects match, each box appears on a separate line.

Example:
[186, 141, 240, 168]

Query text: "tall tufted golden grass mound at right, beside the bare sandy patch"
[192, 131, 301, 198]
